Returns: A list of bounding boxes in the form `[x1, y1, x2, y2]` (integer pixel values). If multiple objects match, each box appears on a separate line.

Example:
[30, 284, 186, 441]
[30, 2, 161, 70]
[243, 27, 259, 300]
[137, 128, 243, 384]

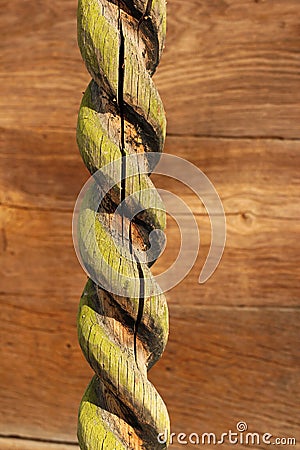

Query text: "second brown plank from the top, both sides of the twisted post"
[0, 128, 300, 220]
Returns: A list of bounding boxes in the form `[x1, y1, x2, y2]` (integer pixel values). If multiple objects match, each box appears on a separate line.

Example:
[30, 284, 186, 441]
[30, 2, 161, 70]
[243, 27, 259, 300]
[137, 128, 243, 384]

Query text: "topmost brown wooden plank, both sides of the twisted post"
[0, 0, 300, 138]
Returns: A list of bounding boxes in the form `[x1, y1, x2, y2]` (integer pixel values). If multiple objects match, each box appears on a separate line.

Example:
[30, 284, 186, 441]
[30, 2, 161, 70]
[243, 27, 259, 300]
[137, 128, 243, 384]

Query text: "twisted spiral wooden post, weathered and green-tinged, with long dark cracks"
[77, 0, 169, 450]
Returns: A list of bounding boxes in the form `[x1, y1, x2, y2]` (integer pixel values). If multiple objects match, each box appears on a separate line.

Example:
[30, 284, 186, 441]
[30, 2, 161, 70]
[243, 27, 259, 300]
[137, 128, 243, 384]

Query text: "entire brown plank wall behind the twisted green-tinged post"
[0, 0, 300, 450]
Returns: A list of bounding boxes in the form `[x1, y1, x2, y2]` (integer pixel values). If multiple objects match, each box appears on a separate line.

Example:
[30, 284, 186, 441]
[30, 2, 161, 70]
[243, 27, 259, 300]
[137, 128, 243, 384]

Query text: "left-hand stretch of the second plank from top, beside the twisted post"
[0, 129, 89, 212]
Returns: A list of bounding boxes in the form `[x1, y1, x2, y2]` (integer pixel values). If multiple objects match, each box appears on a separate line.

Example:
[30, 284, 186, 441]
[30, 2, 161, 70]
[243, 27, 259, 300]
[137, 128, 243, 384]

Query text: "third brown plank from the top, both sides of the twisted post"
[0, 202, 300, 306]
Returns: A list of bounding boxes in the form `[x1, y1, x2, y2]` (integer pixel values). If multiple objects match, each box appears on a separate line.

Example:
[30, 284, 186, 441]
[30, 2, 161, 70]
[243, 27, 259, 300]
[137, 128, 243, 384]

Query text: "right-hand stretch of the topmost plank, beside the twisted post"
[161, 0, 300, 138]
